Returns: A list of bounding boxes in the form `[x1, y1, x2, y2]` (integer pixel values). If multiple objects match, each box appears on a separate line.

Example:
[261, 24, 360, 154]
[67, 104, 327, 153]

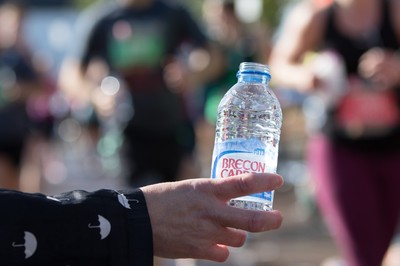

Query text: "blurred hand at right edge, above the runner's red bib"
[358, 48, 400, 88]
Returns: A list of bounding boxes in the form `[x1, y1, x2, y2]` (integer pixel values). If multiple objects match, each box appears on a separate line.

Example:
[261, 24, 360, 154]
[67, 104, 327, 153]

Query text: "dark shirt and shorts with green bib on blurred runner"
[73, 0, 207, 187]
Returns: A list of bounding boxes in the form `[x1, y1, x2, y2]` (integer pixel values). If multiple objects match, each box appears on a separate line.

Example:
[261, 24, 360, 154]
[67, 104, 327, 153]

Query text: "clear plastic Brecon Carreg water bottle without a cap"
[211, 62, 282, 210]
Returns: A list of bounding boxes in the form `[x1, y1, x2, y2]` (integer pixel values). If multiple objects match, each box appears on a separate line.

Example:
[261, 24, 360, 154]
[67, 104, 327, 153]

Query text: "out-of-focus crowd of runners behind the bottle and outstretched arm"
[0, 0, 400, 266]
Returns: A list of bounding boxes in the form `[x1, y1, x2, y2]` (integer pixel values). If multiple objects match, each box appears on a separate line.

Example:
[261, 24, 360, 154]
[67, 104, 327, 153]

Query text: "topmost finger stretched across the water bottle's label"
[214, 173, 283, 200]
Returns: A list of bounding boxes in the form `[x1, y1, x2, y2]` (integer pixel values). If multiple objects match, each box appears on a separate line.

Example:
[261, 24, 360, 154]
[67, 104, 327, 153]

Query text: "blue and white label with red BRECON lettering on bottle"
[211, 139, 276, 202]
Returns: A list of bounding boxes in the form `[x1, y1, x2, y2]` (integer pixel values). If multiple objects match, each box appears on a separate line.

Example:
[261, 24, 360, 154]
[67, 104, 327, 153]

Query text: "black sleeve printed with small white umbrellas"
[0, 189, 153, 266]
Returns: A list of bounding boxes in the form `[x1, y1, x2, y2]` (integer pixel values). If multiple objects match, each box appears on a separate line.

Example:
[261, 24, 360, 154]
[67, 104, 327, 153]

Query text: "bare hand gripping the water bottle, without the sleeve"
[142, 173, 283, 262]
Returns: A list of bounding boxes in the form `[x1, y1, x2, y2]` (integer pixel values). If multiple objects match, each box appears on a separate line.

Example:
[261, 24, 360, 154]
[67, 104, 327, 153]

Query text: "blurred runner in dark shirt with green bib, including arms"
[60, 0, 223, 186]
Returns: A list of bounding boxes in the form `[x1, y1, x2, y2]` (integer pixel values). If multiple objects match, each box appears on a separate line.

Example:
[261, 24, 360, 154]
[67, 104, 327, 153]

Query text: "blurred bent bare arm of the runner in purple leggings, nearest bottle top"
[269, 2, 325, 92]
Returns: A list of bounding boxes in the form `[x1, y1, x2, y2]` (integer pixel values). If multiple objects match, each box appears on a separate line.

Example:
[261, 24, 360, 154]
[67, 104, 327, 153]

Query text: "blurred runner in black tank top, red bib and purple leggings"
[270, 0, 400, 266]
